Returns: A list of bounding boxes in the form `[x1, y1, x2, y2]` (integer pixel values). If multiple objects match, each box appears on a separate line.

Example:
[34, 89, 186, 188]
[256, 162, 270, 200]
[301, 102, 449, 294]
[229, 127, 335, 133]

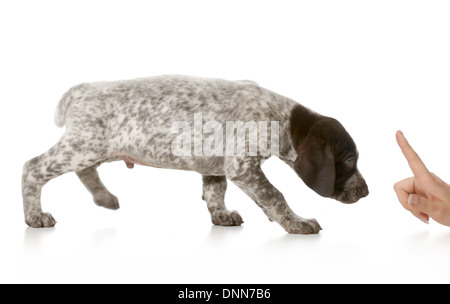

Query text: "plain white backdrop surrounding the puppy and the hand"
[0, 0, 450, 283]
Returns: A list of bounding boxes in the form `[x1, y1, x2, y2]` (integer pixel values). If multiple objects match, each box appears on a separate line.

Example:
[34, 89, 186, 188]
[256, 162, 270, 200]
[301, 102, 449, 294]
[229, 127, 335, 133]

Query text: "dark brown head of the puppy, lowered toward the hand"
[291, 107, 369, 204]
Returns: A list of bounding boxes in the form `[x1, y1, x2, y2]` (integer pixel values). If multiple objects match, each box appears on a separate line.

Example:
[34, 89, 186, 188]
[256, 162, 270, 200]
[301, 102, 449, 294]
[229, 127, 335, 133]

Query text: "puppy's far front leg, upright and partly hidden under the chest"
[202, 175, 244, 226]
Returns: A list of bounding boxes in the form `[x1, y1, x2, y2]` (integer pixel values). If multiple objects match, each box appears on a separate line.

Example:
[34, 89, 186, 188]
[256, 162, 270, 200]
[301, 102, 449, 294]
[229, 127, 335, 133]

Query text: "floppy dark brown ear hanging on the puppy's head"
[294, 136, 336, 197]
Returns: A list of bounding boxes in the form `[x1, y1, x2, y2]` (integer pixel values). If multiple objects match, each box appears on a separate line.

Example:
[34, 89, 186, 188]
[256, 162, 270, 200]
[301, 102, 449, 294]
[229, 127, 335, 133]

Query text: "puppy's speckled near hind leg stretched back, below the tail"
[22, 132, 106, 228]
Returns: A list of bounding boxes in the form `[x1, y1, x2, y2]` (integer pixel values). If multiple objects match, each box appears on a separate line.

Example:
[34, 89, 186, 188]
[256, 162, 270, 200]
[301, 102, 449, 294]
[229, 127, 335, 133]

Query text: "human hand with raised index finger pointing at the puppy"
[394, 131, 450, 226]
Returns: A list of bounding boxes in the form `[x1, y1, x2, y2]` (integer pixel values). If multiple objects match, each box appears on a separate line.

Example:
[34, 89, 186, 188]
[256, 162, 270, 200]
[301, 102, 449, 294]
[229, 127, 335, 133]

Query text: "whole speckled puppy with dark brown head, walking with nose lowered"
[22, 76, 368, 234]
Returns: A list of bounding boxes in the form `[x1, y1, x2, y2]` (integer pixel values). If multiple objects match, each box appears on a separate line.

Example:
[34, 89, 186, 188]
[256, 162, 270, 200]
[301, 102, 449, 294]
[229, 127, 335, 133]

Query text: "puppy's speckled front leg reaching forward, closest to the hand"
[224, 157, 321, 234]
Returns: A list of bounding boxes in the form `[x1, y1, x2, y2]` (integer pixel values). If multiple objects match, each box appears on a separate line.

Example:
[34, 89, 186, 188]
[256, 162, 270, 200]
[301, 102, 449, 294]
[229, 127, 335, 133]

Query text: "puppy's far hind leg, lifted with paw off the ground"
[76, 163, 120, 210]
